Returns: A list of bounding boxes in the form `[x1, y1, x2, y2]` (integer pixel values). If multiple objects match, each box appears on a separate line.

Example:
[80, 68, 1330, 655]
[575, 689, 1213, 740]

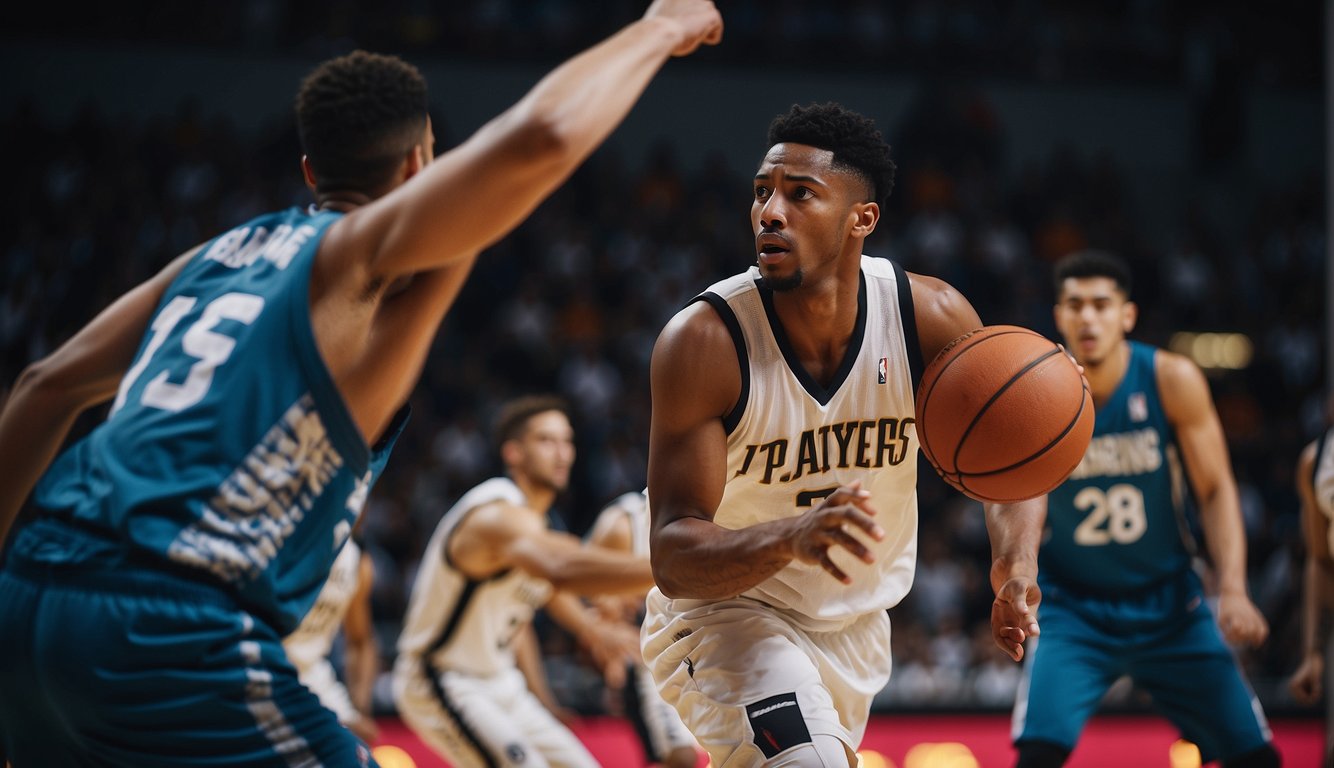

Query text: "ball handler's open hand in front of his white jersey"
[790, 481, 884, 584]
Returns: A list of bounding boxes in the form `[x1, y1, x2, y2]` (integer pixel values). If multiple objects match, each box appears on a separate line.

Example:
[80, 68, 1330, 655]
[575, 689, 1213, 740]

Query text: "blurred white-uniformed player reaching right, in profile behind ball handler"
[394, 396, 652, 768]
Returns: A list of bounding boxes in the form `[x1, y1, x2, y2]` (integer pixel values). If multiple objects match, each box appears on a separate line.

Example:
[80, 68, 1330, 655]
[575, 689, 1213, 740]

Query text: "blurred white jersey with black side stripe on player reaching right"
[399, 477, 552, 676]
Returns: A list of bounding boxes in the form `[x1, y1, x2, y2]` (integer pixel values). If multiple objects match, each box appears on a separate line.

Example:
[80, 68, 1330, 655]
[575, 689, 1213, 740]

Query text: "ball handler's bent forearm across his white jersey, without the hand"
[652, 517, 795, 600]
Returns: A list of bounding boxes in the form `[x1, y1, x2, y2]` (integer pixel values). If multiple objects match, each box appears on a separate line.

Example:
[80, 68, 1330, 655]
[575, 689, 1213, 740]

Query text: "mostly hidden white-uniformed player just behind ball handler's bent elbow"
[588, 491, 699, 768]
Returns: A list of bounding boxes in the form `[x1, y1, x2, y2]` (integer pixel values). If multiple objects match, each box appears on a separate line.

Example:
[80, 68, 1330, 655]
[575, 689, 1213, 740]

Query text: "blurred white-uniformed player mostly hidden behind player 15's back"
[283, 536, 380, 743]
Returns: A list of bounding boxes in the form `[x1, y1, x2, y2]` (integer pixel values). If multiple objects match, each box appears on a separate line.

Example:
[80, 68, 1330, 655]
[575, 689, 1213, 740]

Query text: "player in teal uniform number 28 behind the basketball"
[1014, 252, 1279, 768]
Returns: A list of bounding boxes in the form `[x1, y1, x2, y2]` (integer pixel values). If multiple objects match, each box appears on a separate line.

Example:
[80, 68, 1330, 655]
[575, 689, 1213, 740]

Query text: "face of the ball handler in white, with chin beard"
[751, 144, 874, 291]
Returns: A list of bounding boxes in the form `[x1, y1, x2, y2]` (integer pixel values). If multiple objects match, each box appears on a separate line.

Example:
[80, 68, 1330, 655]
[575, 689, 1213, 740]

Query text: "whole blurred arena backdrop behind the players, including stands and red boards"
[0, 0, 1330, 768]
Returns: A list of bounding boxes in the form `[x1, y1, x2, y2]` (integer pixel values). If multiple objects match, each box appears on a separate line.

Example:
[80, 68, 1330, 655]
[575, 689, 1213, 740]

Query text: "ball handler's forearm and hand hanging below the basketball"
[983, 496, 1047, 661]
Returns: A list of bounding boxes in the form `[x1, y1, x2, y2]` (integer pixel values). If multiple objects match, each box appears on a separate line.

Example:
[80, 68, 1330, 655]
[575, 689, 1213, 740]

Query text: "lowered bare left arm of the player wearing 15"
[0, 248, 199, 544]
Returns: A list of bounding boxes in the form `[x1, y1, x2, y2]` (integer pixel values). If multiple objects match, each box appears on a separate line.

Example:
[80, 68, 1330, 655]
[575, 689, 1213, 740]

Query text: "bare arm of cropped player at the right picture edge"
[1287, 443, 1334, 704]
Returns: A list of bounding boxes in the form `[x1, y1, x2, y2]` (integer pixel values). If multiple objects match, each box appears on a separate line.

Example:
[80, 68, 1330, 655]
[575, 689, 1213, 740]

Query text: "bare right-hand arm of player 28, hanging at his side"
[1157, 351, 1269, 645]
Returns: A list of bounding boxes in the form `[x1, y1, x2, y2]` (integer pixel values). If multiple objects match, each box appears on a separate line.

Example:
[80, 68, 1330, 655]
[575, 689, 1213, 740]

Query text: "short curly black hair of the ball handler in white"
[768, 101, 894, 205]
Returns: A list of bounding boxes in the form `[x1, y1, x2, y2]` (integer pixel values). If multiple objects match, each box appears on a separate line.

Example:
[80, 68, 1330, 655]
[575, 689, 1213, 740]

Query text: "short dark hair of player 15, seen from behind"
[296, 51, 430, 192]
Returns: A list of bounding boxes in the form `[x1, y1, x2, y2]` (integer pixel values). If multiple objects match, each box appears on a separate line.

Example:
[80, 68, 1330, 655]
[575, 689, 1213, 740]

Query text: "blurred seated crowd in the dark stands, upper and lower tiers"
[0, 0, 1326, 713]
